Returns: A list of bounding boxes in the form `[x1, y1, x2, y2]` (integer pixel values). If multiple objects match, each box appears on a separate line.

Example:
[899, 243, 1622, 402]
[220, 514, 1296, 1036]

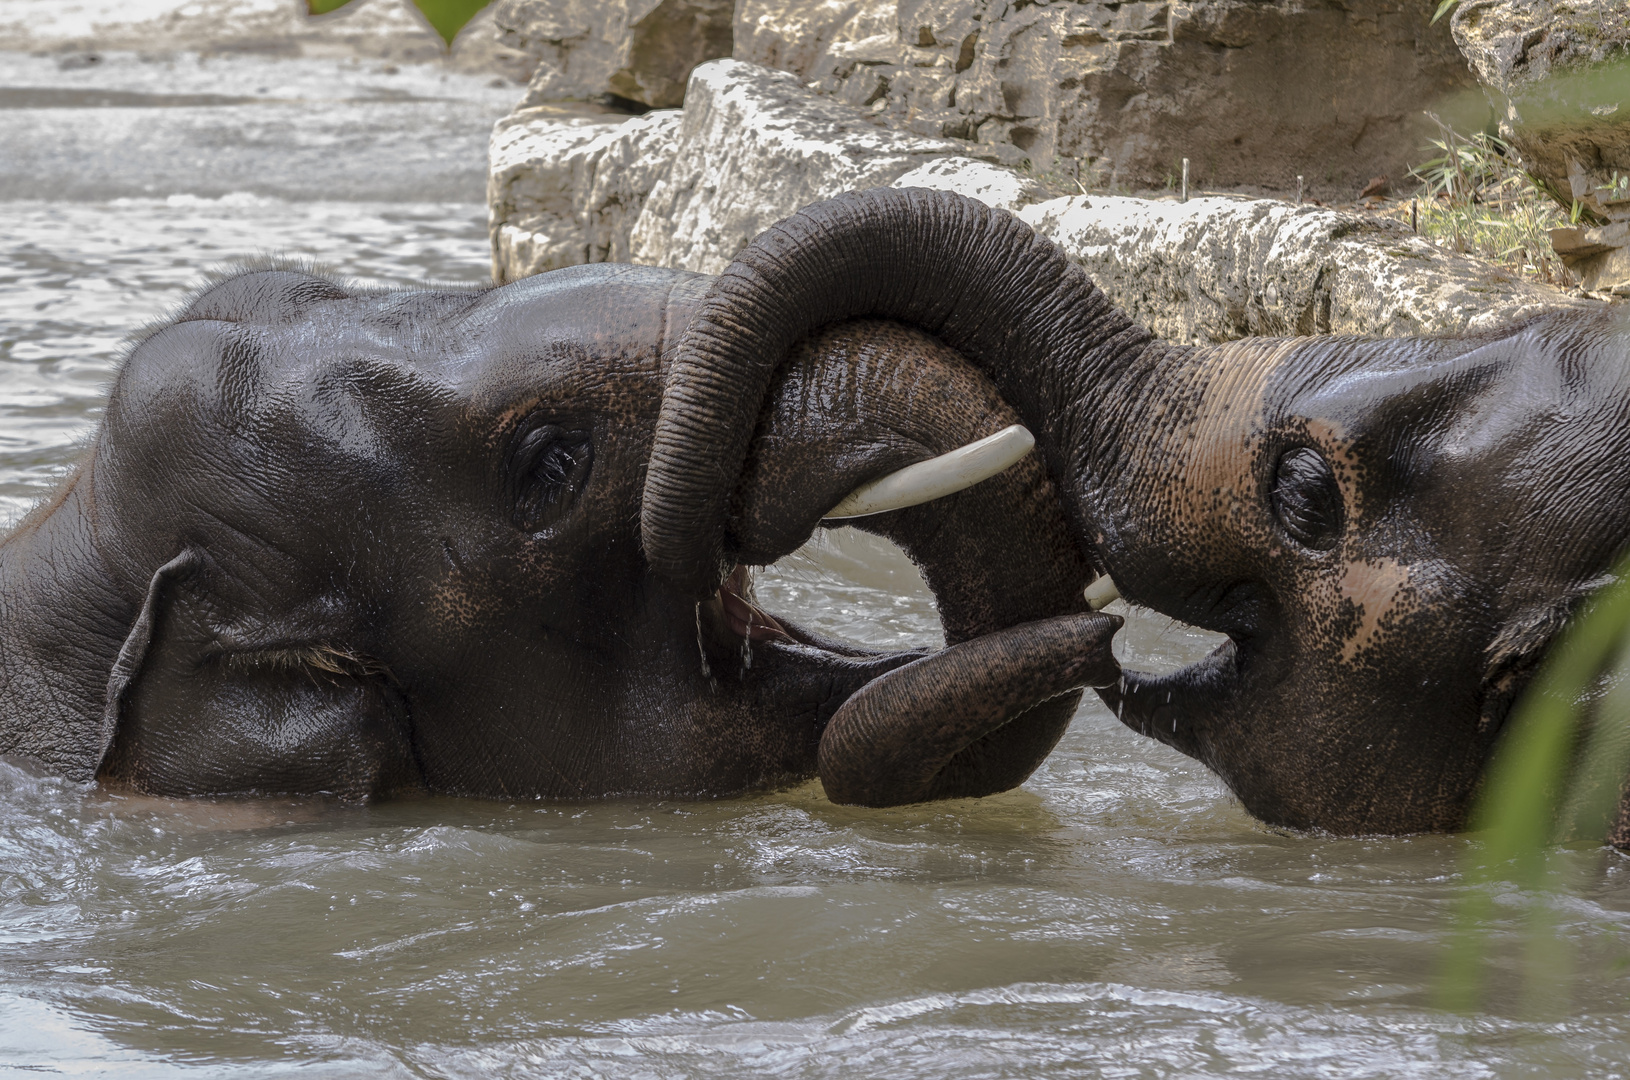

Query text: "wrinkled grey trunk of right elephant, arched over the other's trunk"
[641, 187, 1151, 598]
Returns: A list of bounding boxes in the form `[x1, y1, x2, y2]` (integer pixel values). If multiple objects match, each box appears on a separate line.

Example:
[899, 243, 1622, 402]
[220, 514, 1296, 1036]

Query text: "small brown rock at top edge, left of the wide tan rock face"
[494, 0, 734, 109]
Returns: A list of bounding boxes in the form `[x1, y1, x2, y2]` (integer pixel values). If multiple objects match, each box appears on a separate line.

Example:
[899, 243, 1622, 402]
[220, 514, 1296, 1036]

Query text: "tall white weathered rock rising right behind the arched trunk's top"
[629, 60, 1015, 274]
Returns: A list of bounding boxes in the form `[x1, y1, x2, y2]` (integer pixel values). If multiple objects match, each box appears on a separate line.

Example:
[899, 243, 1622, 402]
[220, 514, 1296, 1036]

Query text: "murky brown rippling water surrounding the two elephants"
[0, 44, 1630, 1080]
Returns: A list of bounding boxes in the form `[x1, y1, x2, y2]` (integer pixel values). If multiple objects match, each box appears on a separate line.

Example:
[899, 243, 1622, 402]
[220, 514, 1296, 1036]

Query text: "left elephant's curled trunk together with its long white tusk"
[661, 321, 1120, 805]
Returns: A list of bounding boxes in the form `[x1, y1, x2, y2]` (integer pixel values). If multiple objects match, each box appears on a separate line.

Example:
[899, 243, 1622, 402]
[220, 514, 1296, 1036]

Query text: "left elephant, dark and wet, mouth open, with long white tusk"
[0, 266, 1118, 801]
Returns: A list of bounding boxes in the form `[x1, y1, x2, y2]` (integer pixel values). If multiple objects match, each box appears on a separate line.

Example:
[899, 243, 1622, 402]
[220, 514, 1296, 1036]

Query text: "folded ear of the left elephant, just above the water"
[98, 547, 419, 798]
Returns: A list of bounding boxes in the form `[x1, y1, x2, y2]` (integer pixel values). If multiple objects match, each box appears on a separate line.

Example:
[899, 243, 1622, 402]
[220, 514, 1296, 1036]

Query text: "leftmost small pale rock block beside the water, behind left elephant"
[487, 106, 680, 283]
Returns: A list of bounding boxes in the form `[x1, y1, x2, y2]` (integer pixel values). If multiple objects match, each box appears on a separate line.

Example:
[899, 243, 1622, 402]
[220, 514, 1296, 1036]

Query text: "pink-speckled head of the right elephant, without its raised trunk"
[1102, 316, 1630, 832]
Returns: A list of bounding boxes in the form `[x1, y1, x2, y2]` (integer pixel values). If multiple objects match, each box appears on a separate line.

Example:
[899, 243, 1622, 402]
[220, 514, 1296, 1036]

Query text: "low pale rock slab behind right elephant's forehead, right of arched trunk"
[1019, 195, 1583, 342]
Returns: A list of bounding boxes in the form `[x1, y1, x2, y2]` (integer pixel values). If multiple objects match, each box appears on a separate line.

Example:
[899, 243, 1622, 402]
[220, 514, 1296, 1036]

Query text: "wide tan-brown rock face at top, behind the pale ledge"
[735, 0, 1474, 199]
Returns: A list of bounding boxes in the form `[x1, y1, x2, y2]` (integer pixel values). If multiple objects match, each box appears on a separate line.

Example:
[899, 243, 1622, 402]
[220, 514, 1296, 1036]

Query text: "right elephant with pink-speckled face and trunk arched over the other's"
[642, 189, 1630, 834]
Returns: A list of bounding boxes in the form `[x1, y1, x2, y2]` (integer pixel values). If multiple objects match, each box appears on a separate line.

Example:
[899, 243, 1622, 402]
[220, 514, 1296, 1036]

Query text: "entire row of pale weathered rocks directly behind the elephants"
[491, 60, 1581, 333]
